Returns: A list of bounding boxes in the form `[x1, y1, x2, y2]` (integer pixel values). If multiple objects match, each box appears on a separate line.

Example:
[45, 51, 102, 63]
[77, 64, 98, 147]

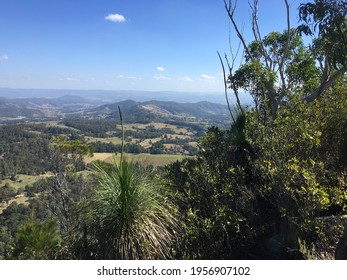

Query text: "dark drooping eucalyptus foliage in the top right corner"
[298, 0, 347, 102]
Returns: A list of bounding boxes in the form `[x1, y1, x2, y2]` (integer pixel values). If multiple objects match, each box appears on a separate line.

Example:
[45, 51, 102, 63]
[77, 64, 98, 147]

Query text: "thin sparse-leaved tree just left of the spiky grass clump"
[47, 136, 91, 234]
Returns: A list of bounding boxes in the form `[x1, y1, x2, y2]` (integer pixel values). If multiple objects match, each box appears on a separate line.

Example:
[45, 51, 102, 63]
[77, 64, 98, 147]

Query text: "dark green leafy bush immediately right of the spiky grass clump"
[166, 110, 256, 259]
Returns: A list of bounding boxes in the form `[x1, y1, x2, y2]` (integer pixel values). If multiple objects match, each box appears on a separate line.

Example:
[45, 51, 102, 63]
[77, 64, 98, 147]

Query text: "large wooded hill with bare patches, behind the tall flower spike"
[87, 100, 229, 122]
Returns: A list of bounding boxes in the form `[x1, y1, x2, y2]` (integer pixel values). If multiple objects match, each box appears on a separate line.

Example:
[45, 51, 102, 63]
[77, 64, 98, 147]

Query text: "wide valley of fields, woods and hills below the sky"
[0, 89, 234, 213]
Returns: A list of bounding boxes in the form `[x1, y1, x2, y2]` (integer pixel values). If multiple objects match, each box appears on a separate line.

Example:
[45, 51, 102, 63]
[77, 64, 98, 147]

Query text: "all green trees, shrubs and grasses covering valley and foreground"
[0, 0, 347, 259]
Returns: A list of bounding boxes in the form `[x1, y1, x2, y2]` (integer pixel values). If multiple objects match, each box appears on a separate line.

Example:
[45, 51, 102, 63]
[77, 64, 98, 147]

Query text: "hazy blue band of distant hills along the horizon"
[0, 88, 237, 123]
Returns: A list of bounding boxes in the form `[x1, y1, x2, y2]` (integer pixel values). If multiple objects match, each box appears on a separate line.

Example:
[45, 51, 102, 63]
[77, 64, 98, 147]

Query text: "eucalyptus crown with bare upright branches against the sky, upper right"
[221, 0, 347, 122]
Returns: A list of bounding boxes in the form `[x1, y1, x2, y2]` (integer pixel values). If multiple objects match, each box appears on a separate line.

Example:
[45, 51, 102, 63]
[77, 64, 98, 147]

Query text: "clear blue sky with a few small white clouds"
[0, 0, 300, 92]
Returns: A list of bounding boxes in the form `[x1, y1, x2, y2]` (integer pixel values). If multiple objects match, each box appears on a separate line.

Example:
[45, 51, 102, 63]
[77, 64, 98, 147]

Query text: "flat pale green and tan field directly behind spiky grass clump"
[85, 153, 186, 166]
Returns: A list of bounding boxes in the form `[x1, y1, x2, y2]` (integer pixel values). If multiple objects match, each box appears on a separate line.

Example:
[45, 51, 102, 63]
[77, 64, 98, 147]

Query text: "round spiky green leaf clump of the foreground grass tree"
[92, 158, 179, 259]
